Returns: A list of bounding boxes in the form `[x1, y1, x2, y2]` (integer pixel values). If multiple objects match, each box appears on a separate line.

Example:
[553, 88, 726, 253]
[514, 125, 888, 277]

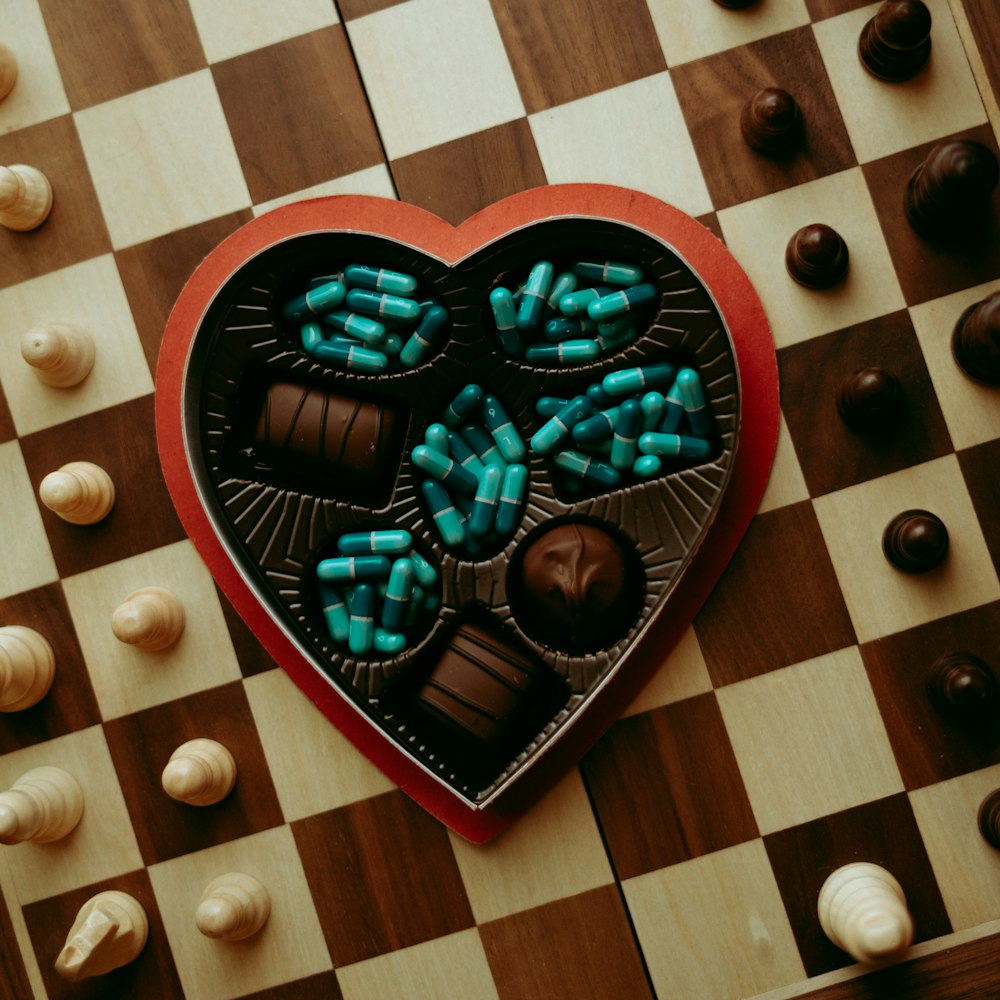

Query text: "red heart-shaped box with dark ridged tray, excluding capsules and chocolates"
[156, 185, 778, 842]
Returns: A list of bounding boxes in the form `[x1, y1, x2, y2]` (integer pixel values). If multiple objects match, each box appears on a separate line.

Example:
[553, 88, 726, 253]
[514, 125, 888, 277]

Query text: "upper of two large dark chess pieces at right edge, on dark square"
[903, 139, 1000, 239]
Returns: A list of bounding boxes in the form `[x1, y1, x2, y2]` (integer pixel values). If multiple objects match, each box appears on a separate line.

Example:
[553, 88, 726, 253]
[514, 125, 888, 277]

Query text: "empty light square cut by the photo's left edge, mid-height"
[0, 441, 59, 596]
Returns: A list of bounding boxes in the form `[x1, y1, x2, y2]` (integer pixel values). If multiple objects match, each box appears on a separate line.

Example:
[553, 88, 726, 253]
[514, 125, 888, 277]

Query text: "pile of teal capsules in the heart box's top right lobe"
[490, 260, 660, 365]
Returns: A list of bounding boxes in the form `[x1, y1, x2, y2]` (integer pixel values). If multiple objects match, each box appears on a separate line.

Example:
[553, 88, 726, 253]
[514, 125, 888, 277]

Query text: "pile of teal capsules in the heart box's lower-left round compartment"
[316, 528, 440, 656]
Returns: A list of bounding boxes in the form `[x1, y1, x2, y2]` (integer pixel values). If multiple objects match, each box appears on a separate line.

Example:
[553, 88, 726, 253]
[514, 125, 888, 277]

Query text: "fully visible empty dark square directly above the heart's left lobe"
[212, 24, 382, 202]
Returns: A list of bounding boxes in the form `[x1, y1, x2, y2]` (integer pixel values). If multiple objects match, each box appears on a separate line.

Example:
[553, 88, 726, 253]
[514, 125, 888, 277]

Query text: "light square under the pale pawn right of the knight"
[149, 826, 333, 1000]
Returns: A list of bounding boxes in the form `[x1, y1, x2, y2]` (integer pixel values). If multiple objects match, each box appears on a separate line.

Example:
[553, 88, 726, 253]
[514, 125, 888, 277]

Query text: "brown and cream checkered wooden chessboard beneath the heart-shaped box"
[0, 0, 1000, 1000]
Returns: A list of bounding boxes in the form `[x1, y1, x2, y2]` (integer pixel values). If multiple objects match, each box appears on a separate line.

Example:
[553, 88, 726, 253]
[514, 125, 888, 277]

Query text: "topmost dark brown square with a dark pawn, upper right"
[670, 25, 857, 209]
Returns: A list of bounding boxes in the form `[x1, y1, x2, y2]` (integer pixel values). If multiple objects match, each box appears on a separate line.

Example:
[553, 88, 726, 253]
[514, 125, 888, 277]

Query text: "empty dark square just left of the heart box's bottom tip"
[292, 791, 475, 967]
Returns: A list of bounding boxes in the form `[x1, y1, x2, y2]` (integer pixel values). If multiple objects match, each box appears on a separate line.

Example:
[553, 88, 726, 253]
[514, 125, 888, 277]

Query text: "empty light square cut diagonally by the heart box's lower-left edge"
[243, 670, 396, 822]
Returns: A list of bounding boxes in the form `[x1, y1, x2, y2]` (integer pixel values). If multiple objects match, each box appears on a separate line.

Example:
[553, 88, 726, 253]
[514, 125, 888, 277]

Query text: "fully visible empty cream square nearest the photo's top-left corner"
[73, 69, 250, 250]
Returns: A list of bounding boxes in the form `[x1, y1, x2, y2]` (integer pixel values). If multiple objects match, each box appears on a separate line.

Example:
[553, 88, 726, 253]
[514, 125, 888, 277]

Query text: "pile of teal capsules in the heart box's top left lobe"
[282, 264, 448, 375]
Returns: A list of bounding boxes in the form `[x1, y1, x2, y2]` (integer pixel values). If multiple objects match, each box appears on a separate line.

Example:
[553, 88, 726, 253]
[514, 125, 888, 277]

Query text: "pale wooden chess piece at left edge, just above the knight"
[0, 766, 83, 844]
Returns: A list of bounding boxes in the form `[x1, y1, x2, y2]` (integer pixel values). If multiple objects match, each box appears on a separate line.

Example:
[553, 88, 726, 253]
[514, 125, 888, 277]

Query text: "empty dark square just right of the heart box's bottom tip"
[582, 692, 758, 879]
